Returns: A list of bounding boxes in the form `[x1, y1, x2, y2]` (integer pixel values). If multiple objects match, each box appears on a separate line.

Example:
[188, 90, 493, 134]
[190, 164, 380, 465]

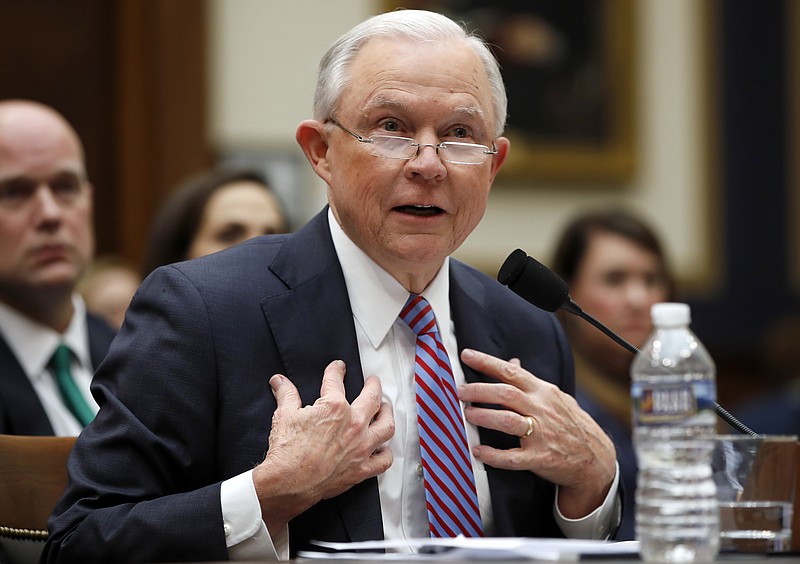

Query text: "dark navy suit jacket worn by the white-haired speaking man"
[43, 210, 574, 562]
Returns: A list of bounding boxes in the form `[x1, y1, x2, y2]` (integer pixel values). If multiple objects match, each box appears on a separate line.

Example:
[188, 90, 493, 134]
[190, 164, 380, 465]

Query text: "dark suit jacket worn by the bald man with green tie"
[0, 315, 114, 435]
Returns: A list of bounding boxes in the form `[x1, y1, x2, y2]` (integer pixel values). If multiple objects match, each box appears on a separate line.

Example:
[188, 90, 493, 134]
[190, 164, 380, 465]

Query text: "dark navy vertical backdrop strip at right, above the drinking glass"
[688, 0, 800, 403]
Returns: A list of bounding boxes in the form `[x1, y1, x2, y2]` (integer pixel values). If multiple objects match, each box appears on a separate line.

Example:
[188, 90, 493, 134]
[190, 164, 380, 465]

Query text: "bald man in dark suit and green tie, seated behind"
[0, 100, 114, 435]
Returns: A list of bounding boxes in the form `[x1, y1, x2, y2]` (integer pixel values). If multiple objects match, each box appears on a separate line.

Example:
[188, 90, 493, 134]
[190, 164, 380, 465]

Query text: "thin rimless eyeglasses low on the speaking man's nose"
[328, 118, 497, 164]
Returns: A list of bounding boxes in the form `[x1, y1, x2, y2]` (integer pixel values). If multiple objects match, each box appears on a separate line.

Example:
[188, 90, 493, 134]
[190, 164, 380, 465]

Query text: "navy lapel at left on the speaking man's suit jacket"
[261, 208, 383, 541]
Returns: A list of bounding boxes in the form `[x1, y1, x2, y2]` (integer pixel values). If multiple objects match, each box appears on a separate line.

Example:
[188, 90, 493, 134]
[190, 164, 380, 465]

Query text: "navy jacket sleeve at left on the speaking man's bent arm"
[42, 267, 228, 562]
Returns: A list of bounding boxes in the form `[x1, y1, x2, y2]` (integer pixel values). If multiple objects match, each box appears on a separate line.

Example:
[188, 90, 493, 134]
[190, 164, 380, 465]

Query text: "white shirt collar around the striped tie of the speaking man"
[328, 208, 450, 348]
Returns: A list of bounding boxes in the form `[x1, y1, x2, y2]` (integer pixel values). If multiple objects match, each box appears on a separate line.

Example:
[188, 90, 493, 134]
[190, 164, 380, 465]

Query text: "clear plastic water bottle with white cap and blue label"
[631, 303, 719, 562]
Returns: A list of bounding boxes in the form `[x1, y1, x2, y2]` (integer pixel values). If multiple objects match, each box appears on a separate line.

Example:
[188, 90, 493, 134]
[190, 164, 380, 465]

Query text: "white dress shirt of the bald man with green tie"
[0, 294, 99, 437]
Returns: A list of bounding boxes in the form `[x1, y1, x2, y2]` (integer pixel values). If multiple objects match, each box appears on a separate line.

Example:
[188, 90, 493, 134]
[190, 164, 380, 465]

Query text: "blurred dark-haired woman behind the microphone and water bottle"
[552, 208, 674, 540]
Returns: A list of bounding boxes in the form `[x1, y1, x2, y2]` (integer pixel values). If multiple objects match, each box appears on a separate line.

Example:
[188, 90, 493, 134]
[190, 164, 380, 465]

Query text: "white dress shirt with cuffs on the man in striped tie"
[222, 211, 619, 559]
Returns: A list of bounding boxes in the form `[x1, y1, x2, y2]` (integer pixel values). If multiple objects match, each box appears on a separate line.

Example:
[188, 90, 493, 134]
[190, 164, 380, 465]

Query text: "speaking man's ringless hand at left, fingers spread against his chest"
[253, 360, 394, 534]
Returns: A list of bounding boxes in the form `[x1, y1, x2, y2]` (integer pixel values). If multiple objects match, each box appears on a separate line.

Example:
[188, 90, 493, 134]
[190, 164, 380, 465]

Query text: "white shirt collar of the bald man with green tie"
[0, 294, 92, 378]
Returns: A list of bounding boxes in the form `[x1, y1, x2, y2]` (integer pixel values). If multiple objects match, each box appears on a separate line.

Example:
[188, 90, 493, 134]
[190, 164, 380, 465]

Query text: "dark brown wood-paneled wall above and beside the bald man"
[0, 0, 212, 264]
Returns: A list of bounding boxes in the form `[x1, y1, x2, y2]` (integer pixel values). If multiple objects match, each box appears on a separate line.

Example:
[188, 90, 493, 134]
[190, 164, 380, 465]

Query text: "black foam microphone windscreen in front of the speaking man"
[497, 249, 569, 311]
